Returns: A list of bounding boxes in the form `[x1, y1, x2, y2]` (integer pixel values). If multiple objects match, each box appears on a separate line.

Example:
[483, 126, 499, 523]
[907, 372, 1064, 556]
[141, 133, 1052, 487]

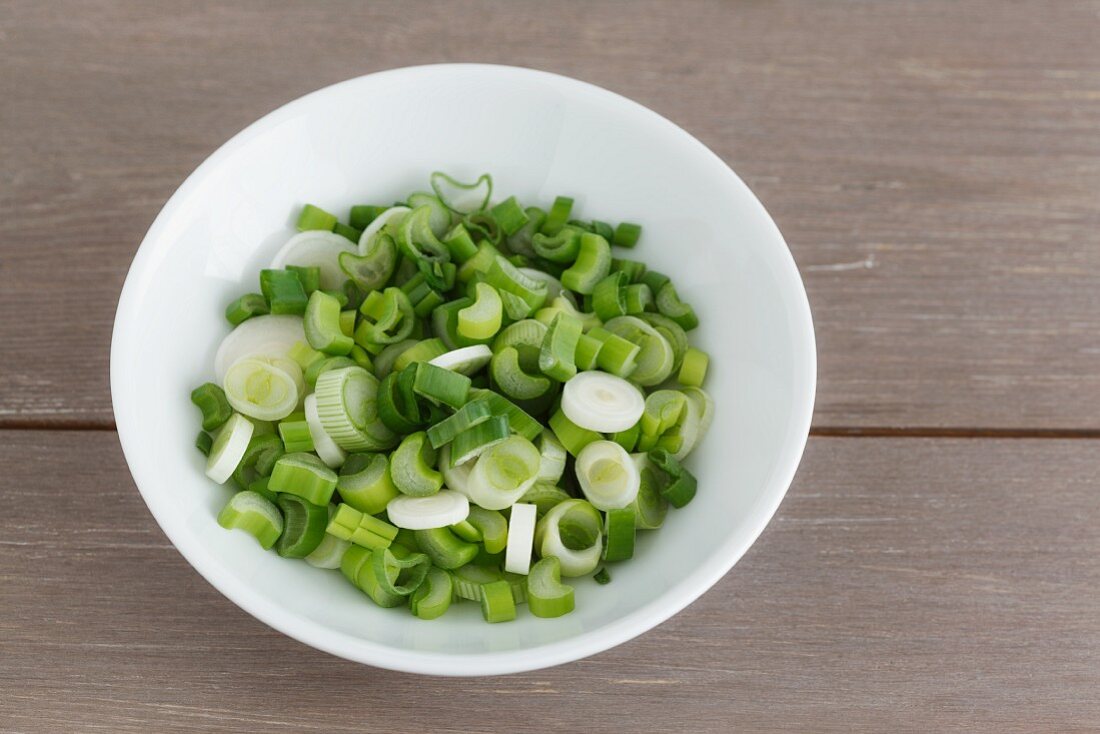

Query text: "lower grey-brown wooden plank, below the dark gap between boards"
[0, 431, 1100, 734]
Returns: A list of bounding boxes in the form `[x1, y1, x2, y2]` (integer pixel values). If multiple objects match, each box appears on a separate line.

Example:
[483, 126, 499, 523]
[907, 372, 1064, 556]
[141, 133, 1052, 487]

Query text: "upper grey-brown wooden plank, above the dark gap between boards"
[0, 0, 1100, 430]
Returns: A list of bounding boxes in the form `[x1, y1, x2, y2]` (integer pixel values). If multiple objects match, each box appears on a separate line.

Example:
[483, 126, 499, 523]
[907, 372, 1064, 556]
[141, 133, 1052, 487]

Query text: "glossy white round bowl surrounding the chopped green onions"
[111, 64, 815, 676]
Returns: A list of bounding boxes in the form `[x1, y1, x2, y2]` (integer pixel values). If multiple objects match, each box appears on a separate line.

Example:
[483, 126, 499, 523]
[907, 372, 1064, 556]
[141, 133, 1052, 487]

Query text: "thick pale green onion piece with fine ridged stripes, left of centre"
[316, 366, 397, 451]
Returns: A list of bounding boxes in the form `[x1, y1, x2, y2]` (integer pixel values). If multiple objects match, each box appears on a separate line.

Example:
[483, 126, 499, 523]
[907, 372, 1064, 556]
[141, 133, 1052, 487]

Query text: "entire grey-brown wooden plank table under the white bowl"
[0, 0, 1100, 732]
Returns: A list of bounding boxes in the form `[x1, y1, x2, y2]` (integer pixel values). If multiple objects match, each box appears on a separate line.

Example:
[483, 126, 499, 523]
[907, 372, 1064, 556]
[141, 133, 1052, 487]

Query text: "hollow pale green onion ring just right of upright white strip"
[535, 500, 604, 577]
